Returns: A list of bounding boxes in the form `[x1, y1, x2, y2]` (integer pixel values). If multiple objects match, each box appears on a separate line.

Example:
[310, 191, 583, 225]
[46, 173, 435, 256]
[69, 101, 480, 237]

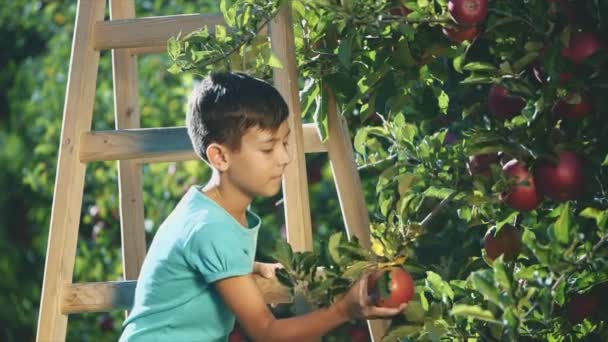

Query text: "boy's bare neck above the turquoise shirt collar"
[202, 170, 252, 227]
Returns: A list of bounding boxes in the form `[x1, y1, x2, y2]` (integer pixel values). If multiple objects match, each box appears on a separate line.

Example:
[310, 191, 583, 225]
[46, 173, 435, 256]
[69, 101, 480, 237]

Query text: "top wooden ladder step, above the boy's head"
[93, 13, 266, 54]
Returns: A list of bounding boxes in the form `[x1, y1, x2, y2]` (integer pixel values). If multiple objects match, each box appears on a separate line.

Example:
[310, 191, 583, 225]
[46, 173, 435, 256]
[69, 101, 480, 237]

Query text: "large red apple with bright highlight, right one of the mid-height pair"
[535, 151, 585, 201]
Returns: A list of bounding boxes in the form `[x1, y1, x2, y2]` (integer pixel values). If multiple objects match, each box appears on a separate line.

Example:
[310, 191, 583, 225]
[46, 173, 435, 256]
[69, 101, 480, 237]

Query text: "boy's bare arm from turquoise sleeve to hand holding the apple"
[215, 275, 404, 342]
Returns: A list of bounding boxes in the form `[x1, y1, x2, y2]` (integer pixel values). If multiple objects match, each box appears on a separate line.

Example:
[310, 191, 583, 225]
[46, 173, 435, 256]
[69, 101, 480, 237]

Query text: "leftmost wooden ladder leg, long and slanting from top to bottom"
[36, 0, 106, 342]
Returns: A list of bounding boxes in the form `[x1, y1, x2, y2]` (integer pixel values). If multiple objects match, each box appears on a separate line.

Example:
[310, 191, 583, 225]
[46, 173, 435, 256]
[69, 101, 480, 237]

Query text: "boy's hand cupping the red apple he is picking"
[336, 273, 407, 320]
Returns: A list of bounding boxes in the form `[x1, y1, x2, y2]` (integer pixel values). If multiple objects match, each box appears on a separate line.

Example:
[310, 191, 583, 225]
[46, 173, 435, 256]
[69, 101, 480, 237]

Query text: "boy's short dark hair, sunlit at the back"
[186, 72, 289, 161]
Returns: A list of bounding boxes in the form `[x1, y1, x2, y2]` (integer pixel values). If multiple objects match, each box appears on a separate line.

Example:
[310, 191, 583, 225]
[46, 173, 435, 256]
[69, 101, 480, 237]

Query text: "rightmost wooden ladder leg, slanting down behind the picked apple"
[325, 89, 390, 341]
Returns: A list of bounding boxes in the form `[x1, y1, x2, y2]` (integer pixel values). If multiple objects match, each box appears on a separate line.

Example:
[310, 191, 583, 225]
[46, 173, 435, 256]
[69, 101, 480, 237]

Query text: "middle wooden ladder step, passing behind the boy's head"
[80, 123, 327, 163]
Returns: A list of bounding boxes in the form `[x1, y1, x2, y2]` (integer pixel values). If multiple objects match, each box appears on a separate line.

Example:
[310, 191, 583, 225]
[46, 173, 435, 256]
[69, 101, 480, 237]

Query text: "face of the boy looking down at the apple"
[226, 121, 291, 197]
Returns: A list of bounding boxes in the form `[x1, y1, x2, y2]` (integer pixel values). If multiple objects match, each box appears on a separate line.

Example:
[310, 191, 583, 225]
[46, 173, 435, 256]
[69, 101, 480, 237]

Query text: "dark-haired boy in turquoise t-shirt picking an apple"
[120, 73, 404, 342]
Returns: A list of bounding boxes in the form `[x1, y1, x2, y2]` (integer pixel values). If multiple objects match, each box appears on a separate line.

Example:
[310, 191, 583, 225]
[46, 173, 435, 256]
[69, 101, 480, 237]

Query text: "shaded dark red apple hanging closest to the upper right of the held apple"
[484, 225, 521, 261]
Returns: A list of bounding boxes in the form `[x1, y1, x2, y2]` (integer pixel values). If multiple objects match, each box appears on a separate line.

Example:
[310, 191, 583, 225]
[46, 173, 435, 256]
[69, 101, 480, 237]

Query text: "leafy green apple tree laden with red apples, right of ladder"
[168, 0, 608, 341]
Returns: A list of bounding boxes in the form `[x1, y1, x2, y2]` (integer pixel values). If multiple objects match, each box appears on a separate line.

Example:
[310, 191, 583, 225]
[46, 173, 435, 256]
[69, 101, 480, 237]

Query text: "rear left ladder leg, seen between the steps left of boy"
[110, 0, 146, 280]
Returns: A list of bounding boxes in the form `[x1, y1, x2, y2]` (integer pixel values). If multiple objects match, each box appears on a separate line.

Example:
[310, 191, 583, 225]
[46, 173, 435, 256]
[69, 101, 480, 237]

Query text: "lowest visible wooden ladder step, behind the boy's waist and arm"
[61, 275, 292, 315]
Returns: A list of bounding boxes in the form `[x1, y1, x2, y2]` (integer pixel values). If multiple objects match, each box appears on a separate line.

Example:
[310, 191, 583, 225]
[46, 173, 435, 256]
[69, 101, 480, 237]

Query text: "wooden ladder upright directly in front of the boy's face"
[270, 2, 313, 251]
